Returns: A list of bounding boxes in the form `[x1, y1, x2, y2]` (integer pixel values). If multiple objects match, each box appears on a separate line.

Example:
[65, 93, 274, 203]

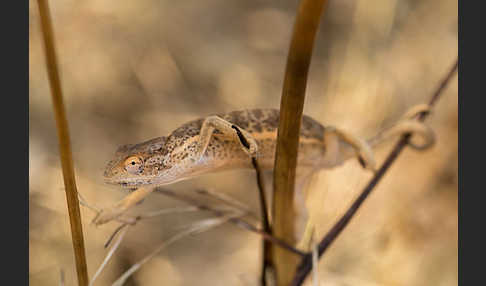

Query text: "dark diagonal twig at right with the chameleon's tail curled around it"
[291, 60, 458, 286]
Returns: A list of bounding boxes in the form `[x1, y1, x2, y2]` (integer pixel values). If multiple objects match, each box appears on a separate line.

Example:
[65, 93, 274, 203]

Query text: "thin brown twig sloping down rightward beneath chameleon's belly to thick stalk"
[154, 188, 306, 257]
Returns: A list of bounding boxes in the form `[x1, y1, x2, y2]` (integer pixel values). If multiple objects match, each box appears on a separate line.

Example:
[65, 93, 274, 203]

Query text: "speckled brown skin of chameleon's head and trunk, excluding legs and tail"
[104, 109, 326, 188]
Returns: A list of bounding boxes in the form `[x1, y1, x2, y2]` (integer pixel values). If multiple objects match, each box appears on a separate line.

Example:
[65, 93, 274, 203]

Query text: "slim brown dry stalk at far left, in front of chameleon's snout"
[37, 0, 88, 286]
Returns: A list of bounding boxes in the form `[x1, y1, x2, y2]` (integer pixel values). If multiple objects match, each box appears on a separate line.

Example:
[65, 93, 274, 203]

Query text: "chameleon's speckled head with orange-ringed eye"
[104, 137, 182, 189]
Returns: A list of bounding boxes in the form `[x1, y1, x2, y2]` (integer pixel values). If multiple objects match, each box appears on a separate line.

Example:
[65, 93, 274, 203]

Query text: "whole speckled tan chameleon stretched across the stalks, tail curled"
[93, 105, 435, 225]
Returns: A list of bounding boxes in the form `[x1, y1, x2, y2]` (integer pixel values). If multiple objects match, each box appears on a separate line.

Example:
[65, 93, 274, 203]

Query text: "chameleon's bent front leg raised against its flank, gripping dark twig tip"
[194, 115, 258, 160]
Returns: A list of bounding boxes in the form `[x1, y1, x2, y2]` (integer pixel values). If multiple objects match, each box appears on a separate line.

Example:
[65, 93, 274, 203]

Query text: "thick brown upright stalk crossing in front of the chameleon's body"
[271, 0, 327, 285]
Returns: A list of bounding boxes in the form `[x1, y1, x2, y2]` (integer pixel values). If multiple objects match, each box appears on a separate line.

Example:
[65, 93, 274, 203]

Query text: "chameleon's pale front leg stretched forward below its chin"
[92, 188, 154, 225]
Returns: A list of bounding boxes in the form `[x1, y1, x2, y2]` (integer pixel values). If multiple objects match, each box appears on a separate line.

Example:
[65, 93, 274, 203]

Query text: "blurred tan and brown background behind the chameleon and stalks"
[29, 0, 458, 285]
